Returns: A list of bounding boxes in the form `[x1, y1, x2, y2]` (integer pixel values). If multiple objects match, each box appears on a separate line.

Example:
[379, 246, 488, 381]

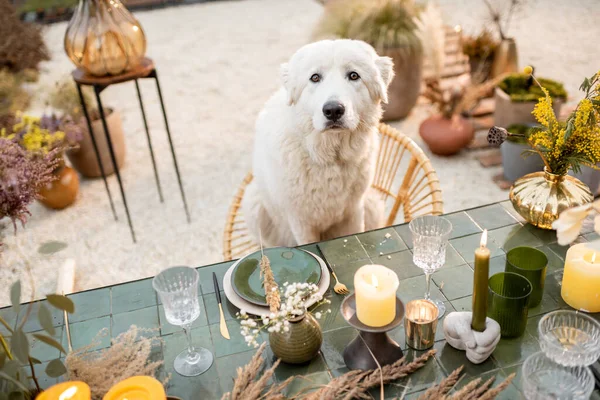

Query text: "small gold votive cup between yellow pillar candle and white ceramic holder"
[404, 300, 439, 350]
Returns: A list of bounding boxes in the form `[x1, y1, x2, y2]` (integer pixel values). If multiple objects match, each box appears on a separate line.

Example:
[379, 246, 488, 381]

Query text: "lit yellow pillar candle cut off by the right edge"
[560, 243, 600, 313]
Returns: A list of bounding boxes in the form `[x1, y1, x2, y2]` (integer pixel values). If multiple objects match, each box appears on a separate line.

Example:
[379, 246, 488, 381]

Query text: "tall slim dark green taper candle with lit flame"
[471, 229, 490, 332]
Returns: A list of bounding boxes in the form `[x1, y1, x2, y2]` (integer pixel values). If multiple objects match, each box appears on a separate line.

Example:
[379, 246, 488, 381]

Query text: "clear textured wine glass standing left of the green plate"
[152, 267, 213, 376]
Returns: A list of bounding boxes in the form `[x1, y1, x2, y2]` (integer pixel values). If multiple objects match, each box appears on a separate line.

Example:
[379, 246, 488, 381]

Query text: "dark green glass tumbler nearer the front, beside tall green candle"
[487, 272, 531, 337]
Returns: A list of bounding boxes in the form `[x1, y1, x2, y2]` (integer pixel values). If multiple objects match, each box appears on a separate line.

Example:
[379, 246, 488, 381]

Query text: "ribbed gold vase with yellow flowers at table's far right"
[488, 67, 600, 229]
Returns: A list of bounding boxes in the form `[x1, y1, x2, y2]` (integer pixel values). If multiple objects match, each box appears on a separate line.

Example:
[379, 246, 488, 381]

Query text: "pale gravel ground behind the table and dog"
[0, 0, 600, 305]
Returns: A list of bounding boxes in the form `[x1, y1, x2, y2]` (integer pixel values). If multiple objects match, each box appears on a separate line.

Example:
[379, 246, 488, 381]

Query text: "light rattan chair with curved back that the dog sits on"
[223, 124, 443, 260]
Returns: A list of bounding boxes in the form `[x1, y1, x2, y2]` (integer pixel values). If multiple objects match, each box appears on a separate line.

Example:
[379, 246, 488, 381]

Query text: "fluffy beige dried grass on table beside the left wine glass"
[65, 325, 168, 400]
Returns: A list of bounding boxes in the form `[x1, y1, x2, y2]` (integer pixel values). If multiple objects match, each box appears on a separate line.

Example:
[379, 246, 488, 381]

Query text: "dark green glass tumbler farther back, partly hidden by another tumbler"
[505, 246, 548, 308]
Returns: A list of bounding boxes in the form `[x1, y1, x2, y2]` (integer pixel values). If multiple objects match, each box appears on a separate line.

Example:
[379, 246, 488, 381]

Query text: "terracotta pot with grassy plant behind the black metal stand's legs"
[47, 79, 125, 178]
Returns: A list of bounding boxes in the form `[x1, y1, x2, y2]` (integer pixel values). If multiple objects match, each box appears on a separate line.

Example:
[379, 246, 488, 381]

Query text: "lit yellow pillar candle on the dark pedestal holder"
[354, 265, 399, 327]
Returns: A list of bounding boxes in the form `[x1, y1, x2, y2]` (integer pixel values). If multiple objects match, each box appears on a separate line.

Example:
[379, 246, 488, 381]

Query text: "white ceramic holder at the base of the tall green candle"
[444, 311, 500, 364]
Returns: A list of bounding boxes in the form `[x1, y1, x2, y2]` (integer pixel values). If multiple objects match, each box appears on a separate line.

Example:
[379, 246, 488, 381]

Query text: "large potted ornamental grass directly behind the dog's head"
[315, 0, 423, 120]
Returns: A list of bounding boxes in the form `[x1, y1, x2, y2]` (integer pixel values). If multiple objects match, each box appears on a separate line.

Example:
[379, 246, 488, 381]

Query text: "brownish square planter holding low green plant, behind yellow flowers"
[494, 88, 563, 128]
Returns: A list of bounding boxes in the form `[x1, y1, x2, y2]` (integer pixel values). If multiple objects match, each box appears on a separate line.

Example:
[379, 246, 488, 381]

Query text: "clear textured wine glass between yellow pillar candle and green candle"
[408, 215, 452, 318]
